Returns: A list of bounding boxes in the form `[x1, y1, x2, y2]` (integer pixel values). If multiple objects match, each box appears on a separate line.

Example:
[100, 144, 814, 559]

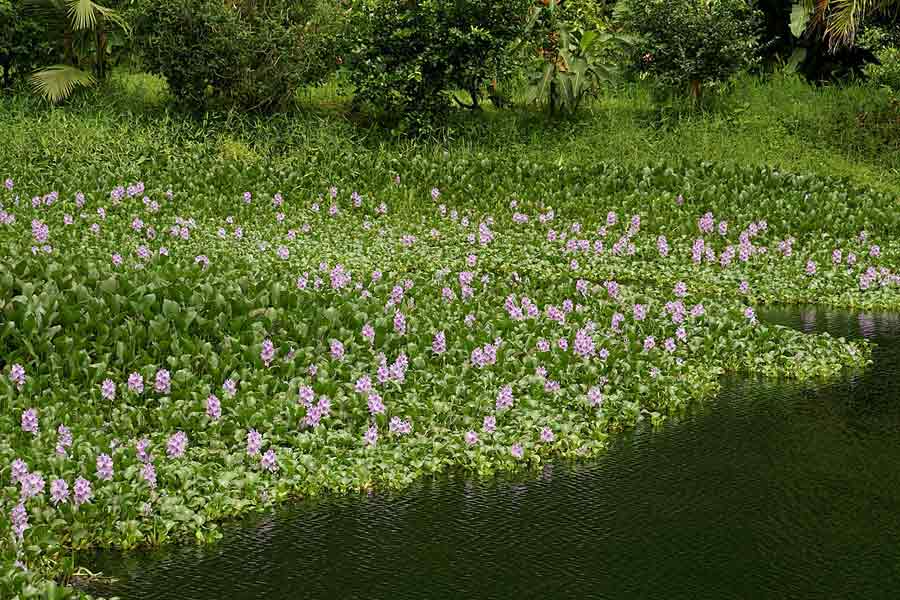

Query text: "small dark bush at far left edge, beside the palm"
[0, 0, 59, 87]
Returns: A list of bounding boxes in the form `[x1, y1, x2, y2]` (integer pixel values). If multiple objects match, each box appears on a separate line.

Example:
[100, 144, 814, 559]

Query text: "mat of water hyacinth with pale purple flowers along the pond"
[0, 173, 900, 594]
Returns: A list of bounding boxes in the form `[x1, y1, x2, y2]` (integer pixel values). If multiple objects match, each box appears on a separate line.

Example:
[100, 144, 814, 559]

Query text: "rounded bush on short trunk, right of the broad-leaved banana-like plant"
[620, 0, 759, 99]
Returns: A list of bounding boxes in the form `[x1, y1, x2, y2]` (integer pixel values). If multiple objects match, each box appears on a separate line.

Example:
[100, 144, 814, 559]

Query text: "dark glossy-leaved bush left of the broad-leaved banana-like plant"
[351, 0, 531, 134]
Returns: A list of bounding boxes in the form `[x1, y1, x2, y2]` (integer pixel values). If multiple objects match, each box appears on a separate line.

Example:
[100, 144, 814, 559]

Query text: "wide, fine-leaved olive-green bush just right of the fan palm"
[134, 0, 342, 110]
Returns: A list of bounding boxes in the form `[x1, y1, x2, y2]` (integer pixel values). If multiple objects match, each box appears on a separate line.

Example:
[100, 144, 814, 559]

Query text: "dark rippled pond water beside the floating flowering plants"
[81, 310, 900, 600]
